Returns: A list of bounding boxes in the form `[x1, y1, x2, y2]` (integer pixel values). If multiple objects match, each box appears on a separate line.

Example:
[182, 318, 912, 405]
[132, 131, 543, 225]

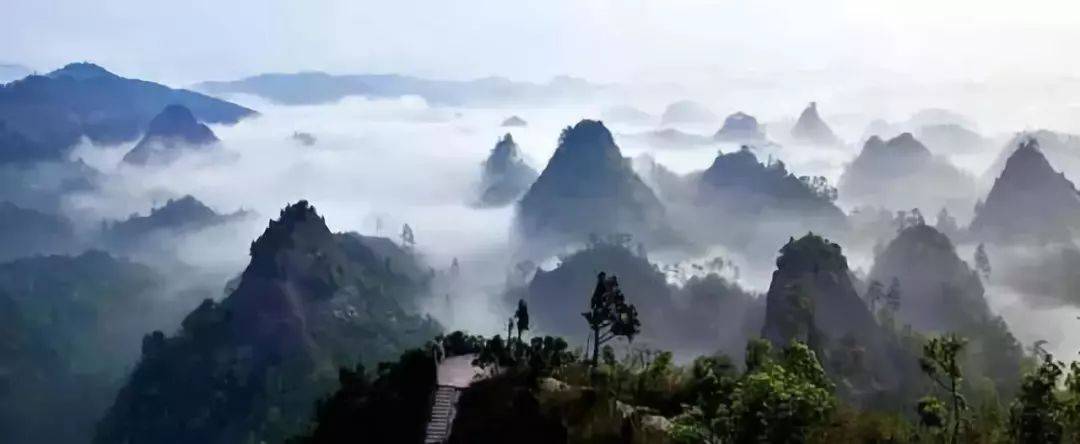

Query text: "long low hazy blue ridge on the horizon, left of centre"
[194, 71, 606, 105]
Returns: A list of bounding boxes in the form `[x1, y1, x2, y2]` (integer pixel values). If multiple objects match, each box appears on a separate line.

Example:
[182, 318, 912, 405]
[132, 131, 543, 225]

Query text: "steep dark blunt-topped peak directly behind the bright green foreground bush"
[761, 234, 917, 403]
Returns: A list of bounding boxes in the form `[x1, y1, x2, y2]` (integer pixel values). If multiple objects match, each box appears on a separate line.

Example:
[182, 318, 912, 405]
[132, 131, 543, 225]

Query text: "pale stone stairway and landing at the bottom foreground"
[423, 354, 481, 444]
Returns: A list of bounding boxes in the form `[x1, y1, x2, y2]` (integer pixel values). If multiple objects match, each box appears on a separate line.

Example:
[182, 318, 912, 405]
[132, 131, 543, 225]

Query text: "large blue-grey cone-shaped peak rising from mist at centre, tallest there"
[517, 120, 670, 248]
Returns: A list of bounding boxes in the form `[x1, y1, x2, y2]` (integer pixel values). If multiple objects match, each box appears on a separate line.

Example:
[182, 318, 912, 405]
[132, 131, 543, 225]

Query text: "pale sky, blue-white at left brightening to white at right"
[6, 0, 1080, 85]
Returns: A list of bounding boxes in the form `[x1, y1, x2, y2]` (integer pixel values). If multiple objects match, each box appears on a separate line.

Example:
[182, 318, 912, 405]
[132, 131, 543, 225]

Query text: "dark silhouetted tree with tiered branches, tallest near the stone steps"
[581, 271, 642, 369]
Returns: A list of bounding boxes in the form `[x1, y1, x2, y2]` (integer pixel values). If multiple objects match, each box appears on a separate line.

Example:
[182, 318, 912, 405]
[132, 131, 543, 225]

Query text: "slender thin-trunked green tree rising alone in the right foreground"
[919, 334, 968, 444]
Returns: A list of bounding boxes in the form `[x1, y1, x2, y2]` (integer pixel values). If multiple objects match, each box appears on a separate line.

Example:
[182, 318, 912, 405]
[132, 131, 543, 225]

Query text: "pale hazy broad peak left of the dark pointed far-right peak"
[838, 133, 975, 211]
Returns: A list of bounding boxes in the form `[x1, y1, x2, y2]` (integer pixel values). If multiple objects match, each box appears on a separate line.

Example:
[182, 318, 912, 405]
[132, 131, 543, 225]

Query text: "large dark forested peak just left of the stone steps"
[94, 201, 438, 443]
